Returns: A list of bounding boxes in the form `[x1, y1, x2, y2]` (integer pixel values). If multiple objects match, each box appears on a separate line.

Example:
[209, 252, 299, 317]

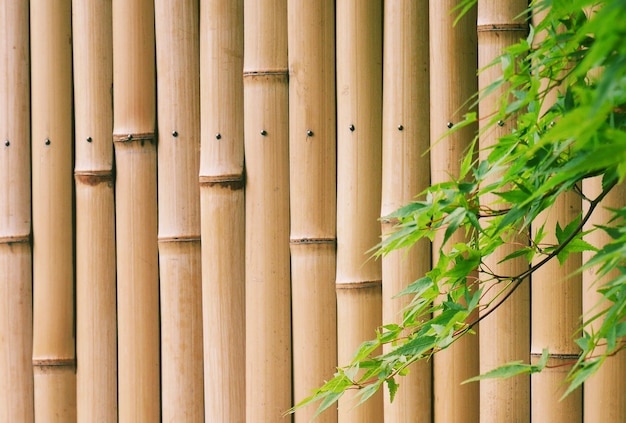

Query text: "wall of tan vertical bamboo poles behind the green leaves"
[0, 0, 626, 423]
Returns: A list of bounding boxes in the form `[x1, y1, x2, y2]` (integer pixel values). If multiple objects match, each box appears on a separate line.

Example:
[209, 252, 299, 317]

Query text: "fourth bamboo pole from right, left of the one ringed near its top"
[430, 0, 480, 423]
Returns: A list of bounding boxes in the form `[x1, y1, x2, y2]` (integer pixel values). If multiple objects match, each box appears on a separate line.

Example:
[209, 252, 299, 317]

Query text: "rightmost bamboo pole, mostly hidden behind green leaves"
[582, 177, 626, 422]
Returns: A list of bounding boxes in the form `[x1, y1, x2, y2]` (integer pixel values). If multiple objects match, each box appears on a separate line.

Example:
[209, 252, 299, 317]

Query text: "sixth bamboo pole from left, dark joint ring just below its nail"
[200, 0, 246, 423]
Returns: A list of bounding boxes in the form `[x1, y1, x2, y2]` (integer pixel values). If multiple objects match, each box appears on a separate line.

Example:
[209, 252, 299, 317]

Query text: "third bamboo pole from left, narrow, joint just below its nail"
[72, 1, 117, 422]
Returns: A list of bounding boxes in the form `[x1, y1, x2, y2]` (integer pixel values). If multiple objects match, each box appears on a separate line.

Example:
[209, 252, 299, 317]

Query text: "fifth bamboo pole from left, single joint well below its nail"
[154, 0, 204, 422]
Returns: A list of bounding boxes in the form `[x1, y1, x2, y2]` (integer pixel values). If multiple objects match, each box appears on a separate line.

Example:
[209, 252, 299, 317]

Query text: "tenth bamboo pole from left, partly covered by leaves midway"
[381, 0, 432, 422]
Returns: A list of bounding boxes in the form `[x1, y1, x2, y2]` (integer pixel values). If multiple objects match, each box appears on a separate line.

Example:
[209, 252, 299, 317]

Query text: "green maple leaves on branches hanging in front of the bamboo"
[288, 0, 626, 418]
